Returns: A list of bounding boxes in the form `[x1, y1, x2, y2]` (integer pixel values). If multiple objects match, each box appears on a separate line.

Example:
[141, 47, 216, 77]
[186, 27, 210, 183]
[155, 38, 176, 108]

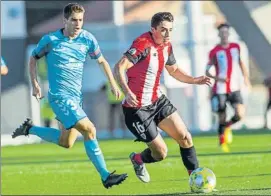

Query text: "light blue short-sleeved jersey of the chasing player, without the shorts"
[32, 29, 102, 97]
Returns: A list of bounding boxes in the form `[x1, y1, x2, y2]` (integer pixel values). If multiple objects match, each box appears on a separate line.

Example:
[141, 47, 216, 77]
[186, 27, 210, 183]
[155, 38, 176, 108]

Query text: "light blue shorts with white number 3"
[49, 96, 87, 130]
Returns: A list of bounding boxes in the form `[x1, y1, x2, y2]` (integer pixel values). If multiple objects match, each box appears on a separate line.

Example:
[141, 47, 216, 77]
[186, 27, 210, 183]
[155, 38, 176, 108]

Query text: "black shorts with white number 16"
[123, 95, 177, 142]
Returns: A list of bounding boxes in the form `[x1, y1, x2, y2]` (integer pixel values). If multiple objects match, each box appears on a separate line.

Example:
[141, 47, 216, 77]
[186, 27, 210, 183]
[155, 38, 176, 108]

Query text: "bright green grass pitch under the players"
[1, 130, 271, 195]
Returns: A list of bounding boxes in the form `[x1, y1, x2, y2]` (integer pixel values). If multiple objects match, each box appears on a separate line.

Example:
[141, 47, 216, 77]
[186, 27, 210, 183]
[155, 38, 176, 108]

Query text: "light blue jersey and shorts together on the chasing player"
[32, 29, 102, 129]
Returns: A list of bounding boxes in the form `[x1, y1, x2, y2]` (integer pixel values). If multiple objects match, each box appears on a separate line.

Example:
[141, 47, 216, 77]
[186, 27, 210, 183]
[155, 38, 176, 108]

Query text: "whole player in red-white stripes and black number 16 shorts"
[114, 12, 210, 182]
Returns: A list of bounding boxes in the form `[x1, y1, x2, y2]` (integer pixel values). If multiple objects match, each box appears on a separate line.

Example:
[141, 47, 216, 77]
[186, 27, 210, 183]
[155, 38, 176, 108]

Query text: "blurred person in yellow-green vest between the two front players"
[101, 82, 126, 137]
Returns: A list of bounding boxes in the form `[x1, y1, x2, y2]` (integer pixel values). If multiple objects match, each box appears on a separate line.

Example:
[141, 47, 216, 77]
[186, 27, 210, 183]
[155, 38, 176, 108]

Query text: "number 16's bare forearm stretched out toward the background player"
[166, 64, 211, 86]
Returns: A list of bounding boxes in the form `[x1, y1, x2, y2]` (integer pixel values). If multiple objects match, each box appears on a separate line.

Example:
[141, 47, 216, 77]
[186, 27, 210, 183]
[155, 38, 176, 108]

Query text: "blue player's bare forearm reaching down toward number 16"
[97, 55, 121, 99]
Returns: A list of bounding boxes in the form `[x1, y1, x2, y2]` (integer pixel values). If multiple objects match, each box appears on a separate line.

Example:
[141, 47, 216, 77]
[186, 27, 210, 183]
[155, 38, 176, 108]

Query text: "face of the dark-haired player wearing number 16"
[151, 21, 173, 44]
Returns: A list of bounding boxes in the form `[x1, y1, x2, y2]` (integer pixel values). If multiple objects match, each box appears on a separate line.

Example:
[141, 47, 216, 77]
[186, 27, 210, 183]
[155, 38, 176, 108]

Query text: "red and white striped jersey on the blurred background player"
[207, 43, 243, 94]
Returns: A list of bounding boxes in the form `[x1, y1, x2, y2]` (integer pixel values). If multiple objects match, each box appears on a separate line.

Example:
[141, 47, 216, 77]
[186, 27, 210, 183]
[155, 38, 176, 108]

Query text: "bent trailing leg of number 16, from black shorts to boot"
[123, 106, 167, 182]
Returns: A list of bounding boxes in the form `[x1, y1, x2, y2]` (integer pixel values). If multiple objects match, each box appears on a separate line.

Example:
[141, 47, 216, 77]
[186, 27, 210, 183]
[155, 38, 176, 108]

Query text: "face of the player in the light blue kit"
[64, 13, 84, 37]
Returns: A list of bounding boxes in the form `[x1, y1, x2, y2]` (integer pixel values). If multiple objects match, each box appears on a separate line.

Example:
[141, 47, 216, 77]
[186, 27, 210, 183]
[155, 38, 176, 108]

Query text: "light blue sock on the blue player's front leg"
[84, 139, 110, 180]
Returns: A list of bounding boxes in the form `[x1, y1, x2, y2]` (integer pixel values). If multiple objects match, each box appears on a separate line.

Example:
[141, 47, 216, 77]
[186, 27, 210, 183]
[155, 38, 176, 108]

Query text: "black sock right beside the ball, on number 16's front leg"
[180, 146, 199, 171]
